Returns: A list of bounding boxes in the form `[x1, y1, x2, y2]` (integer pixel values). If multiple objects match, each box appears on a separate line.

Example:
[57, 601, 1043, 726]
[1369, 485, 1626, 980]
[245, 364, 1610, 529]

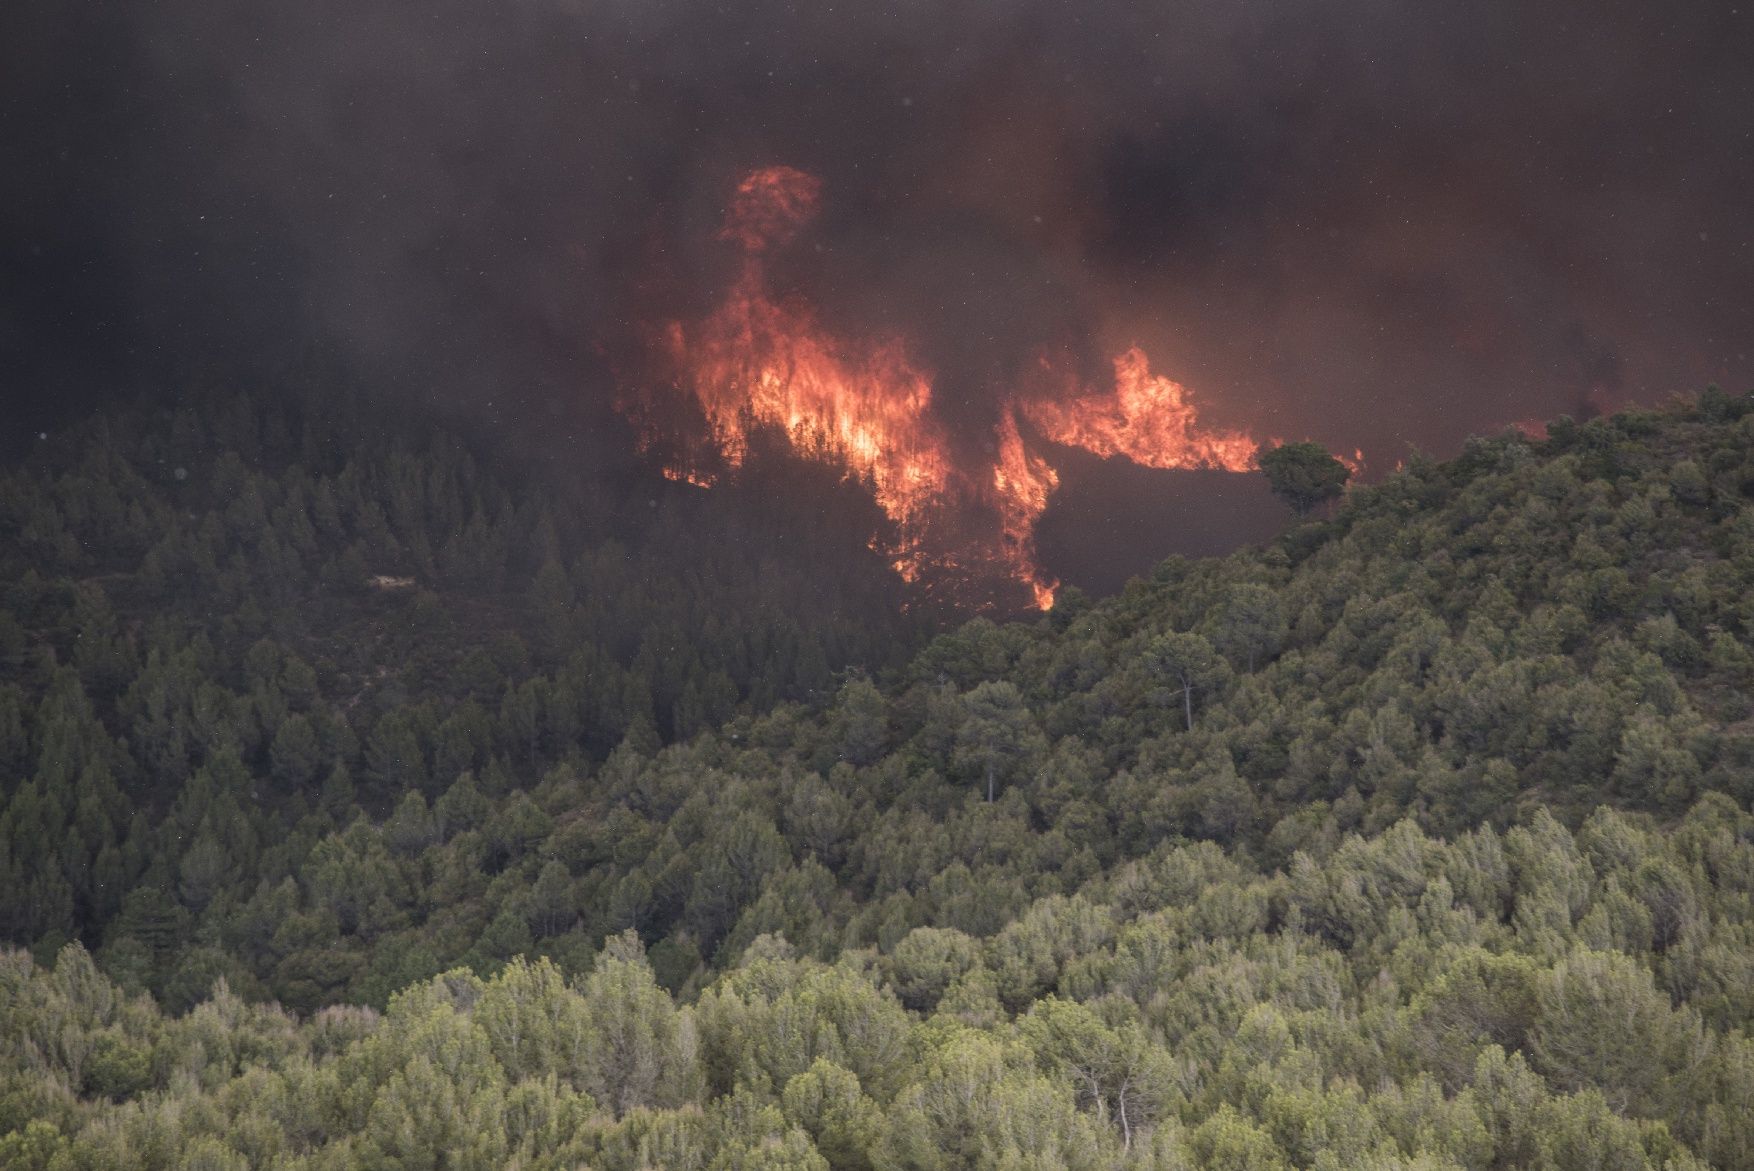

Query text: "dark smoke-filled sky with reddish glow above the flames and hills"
[0, 0, 1754, 466]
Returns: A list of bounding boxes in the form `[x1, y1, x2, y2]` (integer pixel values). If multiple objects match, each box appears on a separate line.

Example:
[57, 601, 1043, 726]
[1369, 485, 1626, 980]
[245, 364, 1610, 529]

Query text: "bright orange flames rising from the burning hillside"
[628, 167, 1259, 610]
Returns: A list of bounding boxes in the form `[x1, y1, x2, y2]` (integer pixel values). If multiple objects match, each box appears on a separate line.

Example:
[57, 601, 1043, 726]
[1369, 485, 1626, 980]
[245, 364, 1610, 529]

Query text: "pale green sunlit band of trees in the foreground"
[0, 796, 1754, 1171]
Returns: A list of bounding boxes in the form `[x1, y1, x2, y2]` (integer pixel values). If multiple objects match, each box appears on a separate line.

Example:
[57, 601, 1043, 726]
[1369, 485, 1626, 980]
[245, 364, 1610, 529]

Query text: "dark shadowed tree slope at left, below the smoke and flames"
[0, 389, 923, 990]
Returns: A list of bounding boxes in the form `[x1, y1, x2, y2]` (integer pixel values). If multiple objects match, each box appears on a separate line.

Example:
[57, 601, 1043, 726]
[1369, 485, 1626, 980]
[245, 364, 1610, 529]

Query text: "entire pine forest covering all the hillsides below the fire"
[0, 389, 1754, 1171]
